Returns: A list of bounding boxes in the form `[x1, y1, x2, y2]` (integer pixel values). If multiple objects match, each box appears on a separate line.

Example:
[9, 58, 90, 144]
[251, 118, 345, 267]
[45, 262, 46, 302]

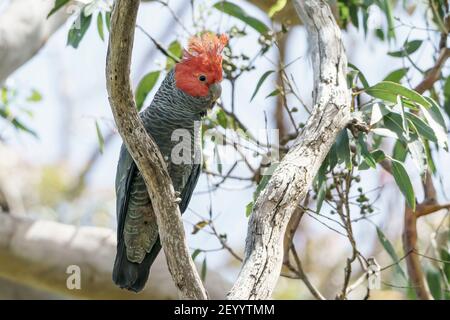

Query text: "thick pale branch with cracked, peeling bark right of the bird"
[228, 0, 351, 299]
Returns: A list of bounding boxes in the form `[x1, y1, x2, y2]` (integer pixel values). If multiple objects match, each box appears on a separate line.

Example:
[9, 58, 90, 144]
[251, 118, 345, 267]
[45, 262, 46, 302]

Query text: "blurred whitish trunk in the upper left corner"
[0, 0, 70, 84]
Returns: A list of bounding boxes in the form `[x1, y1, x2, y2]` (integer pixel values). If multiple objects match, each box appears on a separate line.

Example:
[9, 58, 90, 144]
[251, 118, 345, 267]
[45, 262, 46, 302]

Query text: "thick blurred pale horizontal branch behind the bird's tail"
[0, 212, 230, 299]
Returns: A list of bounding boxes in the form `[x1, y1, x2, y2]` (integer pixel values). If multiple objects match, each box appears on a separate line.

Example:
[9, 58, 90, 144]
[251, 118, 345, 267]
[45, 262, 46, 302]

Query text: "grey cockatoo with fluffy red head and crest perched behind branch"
[112, 32, 228, 292]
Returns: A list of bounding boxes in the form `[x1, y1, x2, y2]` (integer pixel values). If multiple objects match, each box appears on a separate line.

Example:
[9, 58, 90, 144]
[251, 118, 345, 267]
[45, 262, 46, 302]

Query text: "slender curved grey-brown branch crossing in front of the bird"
[106, 0, 207, 299]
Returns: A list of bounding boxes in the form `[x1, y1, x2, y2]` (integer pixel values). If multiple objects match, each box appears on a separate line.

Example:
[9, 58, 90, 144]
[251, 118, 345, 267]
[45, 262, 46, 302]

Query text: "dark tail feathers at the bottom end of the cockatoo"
[113, 237, 161, 292]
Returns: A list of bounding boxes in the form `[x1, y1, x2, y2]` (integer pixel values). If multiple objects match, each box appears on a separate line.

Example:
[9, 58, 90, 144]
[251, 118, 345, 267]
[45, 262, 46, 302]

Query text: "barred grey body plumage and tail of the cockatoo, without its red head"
[113, 70, 217, 291]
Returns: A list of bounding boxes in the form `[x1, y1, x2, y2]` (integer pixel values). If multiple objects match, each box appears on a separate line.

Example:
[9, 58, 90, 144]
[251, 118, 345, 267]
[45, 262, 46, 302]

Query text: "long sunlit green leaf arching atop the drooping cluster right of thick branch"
[366, 81, 431, 109]
